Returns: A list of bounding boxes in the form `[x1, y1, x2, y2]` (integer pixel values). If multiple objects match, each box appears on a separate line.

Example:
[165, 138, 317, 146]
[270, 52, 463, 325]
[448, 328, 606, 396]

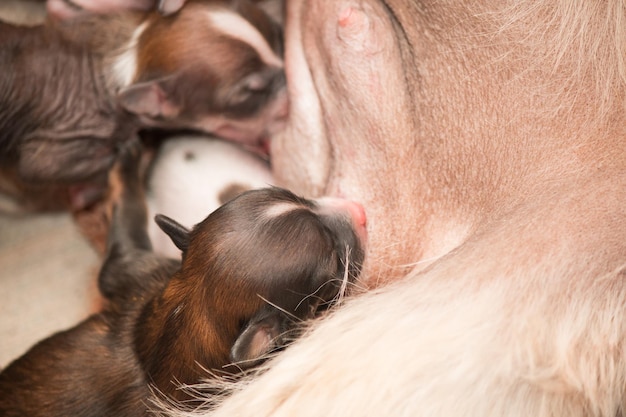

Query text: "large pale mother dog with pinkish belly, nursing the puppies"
[52, 0, 626, 417]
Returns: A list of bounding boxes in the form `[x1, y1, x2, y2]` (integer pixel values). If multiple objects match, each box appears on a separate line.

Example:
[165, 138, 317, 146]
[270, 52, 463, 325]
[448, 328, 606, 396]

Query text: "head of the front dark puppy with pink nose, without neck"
[153, 188, 365, 367]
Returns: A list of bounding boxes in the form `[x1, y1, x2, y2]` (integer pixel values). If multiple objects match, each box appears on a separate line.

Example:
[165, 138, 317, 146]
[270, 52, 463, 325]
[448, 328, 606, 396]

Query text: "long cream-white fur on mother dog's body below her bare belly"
[204, 260, 626, 417]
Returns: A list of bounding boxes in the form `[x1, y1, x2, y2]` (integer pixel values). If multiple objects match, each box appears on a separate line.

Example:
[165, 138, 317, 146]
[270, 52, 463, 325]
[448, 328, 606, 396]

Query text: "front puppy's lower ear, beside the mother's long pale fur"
[230, 311, 283, 369]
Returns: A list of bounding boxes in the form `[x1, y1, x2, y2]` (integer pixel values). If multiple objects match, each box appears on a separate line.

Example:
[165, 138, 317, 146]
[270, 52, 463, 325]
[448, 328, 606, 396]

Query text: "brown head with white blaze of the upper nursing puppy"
[119, 0, 287, 150]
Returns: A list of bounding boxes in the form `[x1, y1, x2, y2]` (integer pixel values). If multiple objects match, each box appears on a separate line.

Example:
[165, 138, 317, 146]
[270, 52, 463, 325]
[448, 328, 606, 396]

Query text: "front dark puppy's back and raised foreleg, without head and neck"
[0, 141, 174, 416]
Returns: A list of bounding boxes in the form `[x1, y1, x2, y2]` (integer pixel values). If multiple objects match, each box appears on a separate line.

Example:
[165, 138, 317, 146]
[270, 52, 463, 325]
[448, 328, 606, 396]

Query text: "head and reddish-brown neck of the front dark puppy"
[140, 188, 365, 399]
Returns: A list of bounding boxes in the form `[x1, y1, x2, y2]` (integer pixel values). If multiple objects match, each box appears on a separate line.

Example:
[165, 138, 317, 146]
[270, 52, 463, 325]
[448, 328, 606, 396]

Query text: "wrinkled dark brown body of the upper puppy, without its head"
[0, 17, 132, 182]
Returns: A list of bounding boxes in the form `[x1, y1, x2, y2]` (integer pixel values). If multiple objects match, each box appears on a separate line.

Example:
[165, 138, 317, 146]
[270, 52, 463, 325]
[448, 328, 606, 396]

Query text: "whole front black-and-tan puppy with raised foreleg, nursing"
[0, 141, 365, 417]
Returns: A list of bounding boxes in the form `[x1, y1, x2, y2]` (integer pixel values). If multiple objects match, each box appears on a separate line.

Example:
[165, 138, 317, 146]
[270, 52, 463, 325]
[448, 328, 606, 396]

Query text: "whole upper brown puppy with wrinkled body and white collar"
[0, 1, 287, 205]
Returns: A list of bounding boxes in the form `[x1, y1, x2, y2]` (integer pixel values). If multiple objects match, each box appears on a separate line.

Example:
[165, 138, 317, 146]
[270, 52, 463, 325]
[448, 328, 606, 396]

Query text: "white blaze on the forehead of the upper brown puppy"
[208, 10, 283, 68]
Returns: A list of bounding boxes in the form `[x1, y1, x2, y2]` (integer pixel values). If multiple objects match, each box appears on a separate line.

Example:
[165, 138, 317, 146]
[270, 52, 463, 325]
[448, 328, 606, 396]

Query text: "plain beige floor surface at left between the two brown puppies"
[0, 208, 100, 368]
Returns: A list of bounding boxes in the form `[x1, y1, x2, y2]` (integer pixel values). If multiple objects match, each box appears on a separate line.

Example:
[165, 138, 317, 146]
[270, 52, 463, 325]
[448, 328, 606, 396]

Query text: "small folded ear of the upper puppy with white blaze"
[118, 77, 181, 121]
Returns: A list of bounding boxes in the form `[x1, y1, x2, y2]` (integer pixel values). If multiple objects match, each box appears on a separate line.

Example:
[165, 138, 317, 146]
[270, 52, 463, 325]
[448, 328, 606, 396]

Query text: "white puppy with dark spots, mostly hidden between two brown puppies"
[147, 135, 274, 258]
